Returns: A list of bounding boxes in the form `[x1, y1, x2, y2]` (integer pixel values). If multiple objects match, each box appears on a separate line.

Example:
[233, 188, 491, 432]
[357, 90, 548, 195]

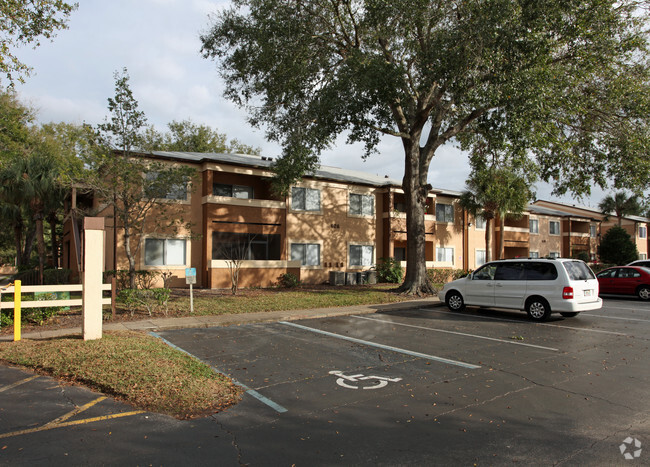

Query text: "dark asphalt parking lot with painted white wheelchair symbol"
[0, 297, 650, 465]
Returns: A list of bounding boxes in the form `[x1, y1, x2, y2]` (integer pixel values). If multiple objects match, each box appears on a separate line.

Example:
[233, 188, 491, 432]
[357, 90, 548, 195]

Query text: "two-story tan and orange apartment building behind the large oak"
[62, 152, 650, 289]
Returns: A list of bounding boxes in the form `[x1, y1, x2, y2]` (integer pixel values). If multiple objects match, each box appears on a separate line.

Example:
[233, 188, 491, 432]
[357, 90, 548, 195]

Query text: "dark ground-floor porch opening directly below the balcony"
[212, 232, 282, 261]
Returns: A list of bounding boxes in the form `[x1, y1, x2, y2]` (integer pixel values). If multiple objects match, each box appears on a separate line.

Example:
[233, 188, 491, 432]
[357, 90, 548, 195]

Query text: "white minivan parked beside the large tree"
[438, 258, 603, 321]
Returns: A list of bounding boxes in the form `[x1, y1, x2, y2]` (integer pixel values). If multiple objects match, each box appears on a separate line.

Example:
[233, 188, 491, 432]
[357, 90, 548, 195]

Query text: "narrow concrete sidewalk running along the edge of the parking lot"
[0, 297, 444, 342]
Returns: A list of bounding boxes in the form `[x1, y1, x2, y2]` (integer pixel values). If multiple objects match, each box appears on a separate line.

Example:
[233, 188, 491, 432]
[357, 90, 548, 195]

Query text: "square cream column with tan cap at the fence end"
[81, 217, 104, 341]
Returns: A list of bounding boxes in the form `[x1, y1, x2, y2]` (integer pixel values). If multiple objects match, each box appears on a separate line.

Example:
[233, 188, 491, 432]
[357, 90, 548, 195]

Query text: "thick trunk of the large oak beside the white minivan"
[397, 143, 435, 296]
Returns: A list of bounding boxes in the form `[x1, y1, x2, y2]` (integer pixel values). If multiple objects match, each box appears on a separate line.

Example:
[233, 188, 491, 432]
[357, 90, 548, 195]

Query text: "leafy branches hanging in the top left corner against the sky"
[0, 0, 78, 83]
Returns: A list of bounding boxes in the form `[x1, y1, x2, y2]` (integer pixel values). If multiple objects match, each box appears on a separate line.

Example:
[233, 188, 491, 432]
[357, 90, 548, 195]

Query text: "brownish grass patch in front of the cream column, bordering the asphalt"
[0, 332, 243, 419]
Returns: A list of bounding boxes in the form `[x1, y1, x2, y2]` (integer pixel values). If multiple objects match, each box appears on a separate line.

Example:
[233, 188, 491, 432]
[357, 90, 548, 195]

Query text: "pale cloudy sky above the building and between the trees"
[11, 0, 607, 207]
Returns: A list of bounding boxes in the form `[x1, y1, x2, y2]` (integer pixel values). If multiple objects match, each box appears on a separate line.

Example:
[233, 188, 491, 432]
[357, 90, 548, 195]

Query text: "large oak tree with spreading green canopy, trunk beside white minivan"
[201, 0, 650, 294]
